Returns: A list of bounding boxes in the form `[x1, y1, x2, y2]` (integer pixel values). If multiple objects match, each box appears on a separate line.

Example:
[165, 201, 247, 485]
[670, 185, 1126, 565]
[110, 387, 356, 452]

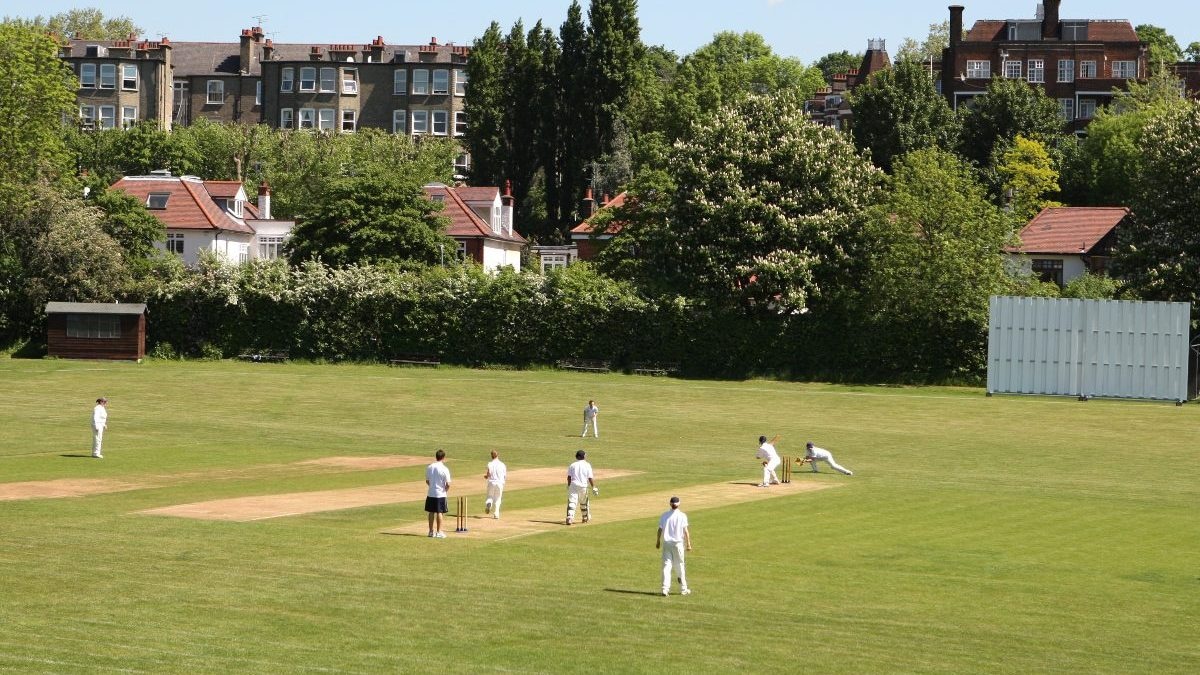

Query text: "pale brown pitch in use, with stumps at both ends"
[383, 482, 834, 540]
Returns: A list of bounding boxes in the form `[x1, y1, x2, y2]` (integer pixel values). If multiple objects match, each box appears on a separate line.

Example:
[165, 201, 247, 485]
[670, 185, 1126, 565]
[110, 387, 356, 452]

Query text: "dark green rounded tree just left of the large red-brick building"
[850, 61, 959, 172]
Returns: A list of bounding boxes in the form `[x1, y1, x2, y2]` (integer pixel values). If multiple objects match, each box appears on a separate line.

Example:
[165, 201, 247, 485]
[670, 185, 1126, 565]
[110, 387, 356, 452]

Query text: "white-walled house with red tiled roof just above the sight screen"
[1007, 207, 1129, 288]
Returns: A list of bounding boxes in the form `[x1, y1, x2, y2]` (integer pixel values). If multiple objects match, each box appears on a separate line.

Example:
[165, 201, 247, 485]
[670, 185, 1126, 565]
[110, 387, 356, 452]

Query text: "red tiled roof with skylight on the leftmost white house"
[113, 175, 254, 234]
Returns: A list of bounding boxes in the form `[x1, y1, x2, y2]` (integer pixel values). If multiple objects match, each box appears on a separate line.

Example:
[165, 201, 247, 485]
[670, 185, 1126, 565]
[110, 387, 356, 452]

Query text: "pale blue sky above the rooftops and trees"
[14, 0, 1200, 64]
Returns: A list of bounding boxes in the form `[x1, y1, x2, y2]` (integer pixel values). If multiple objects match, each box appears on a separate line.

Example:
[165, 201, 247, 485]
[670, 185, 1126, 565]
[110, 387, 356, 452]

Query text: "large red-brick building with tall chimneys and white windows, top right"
[942, 0, 1147, 131]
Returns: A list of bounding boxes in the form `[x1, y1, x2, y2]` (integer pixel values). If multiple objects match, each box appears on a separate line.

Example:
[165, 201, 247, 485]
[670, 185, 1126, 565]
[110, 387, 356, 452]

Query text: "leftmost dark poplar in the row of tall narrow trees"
[463, 22, 509, 185]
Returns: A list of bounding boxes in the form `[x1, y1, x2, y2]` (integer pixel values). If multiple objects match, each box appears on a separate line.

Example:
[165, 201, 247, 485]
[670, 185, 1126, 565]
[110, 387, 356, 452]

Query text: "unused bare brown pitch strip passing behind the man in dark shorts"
[138, 467, 637, 522]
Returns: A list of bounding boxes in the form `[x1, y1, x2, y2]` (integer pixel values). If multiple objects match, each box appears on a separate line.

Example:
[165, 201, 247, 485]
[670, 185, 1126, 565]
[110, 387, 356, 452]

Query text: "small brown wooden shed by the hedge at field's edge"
[46, 303, 146, 360]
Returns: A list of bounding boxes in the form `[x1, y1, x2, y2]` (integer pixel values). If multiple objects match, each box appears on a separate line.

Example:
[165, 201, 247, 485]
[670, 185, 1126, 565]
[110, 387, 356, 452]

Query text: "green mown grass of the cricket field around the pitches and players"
[0, 359, 1200, 674]
